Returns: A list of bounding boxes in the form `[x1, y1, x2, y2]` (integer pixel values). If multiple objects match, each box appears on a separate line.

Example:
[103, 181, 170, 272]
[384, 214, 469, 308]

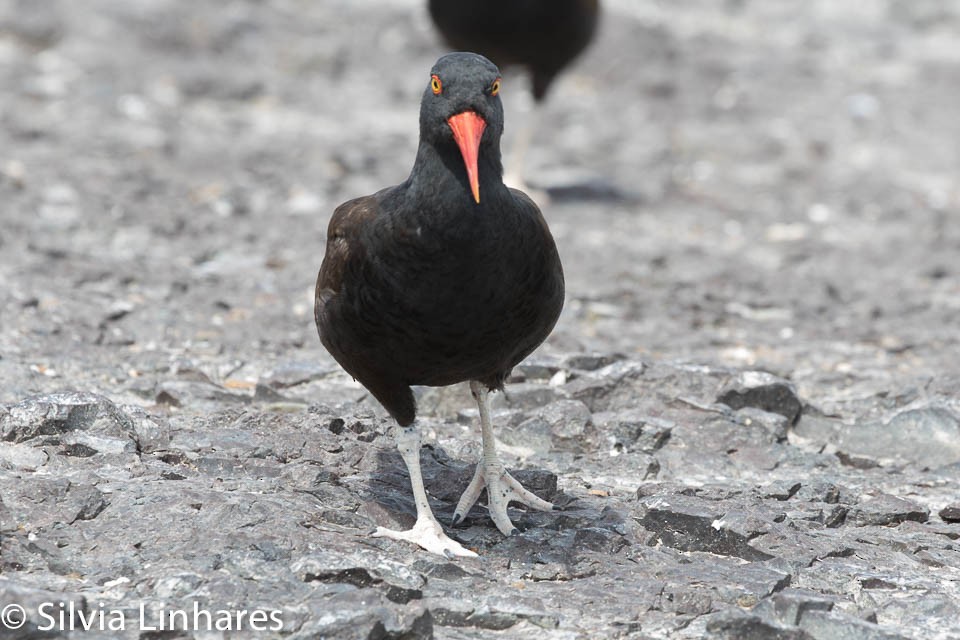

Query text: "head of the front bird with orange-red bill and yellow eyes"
[420, 53, 503, 203]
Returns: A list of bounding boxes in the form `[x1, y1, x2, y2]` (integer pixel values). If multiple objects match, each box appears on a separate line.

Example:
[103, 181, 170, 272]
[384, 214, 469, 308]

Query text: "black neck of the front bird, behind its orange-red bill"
[407, 140, 507, 203]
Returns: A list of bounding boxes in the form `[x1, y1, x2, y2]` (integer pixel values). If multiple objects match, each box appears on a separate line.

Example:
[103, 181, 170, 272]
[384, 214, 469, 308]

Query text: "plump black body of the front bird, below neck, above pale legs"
[315, 188, 564, 424]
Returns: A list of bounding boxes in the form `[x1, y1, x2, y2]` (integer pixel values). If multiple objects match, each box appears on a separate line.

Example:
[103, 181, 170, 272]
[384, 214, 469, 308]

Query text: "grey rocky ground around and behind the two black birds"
[0, 0, 960, 640]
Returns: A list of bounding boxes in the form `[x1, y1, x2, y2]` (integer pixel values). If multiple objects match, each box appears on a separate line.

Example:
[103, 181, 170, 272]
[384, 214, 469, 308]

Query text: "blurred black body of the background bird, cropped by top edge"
[429, 0, 600, 102]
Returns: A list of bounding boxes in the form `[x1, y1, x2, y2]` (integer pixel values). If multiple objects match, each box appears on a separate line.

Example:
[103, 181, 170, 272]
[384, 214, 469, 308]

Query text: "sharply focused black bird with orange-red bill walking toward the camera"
[315, 53, 564, 556]
